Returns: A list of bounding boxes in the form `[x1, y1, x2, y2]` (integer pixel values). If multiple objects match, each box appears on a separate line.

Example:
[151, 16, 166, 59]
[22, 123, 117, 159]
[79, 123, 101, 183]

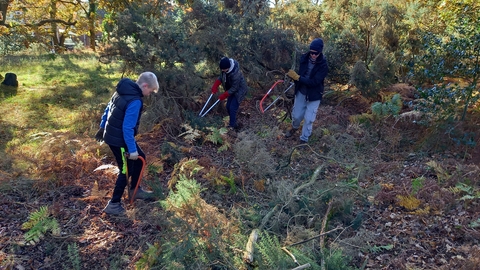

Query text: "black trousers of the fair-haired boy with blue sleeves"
[109, 144, 145, 202]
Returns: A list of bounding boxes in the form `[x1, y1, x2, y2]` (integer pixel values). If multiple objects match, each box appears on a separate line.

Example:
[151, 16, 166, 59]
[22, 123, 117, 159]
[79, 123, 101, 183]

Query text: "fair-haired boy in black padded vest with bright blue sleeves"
[95, 72, 158, 215]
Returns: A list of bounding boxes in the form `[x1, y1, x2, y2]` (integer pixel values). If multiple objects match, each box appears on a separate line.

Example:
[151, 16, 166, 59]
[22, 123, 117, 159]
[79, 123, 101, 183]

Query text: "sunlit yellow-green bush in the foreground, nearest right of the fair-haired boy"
[159, 174, 240, 269]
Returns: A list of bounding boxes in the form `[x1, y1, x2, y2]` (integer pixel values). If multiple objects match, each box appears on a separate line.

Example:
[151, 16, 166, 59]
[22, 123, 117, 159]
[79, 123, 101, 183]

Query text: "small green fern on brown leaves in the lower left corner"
[22, 206, 60, 245]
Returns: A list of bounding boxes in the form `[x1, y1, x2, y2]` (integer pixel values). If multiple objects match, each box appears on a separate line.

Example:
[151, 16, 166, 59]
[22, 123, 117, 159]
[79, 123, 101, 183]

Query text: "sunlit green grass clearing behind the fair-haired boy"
[0, 54, 121, 173]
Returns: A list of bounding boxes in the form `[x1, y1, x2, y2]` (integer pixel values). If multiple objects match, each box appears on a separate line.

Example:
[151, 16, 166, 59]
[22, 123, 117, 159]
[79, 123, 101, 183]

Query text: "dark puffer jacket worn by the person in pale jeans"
[295, 53, 328, 101]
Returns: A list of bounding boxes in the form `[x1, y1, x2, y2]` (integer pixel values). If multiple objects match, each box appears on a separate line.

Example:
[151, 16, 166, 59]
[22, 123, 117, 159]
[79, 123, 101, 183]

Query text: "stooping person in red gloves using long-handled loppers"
[212, 57, 248, 130]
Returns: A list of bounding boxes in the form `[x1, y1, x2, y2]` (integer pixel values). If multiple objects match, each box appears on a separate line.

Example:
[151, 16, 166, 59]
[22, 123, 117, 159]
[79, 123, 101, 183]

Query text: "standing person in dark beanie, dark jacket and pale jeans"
[285, 38, 328, 143]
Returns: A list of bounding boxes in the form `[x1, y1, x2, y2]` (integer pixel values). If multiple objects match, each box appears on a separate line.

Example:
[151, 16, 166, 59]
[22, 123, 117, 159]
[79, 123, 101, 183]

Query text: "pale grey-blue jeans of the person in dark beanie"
[292, 92, 320, 142]
